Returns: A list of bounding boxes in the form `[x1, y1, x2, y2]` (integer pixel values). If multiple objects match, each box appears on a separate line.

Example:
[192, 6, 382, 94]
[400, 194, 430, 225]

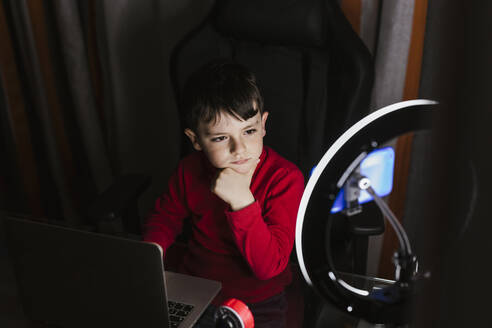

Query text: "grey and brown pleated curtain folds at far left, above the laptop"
[0, 1, 114, 223]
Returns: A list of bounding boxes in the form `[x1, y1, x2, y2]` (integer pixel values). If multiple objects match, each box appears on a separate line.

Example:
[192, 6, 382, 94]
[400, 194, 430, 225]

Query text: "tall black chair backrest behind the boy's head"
[171, 0, 373, 177]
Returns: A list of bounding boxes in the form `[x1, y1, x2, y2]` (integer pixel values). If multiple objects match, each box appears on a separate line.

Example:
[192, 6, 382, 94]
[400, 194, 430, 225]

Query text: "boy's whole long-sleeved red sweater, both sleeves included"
[144, 146, 304, 304]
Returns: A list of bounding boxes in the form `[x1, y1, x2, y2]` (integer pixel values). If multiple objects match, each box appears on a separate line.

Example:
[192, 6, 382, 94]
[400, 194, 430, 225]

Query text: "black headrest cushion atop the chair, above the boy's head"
[214, 0, 328, 47]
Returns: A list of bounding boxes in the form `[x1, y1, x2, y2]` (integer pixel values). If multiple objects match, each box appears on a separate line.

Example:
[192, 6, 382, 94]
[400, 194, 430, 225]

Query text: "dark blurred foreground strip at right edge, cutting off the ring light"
[407, 0, 492, 327]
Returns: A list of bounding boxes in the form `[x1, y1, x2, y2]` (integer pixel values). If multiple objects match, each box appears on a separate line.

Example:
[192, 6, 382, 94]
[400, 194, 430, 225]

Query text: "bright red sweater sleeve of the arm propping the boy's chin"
[226, 170, 304, 280]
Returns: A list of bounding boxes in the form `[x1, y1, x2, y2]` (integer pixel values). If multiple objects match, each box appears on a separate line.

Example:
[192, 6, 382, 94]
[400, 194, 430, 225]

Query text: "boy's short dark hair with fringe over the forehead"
[181, 59, 263, 131]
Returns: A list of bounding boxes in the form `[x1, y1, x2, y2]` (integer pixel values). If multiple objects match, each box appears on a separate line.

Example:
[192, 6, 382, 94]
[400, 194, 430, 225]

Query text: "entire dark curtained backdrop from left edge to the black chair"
[0, 0, 212, 224]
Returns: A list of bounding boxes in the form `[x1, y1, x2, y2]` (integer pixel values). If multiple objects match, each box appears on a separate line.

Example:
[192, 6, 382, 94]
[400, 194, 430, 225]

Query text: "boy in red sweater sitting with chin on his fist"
[144, 61, 304, 327]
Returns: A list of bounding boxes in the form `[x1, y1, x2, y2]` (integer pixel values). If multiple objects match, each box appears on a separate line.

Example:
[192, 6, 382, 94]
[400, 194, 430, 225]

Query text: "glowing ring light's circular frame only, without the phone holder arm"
[296, 99, 437, 323]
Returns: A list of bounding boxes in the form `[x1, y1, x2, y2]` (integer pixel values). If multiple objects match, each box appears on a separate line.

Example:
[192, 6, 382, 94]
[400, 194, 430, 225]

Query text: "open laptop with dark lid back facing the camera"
[4, 216, 221, 328]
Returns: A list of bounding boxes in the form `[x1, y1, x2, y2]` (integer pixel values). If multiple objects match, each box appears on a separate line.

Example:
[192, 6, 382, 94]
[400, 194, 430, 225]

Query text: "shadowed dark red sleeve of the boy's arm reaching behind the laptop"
[143, 165, 190, 252]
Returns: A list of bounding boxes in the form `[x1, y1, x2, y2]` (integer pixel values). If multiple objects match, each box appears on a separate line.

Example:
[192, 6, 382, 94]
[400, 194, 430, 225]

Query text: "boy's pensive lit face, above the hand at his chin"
[185, 111, 268, 173]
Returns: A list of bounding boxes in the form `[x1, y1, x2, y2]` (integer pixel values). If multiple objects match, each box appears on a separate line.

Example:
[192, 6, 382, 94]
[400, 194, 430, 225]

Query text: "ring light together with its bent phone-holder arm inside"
[296, 99, 437, 324]
